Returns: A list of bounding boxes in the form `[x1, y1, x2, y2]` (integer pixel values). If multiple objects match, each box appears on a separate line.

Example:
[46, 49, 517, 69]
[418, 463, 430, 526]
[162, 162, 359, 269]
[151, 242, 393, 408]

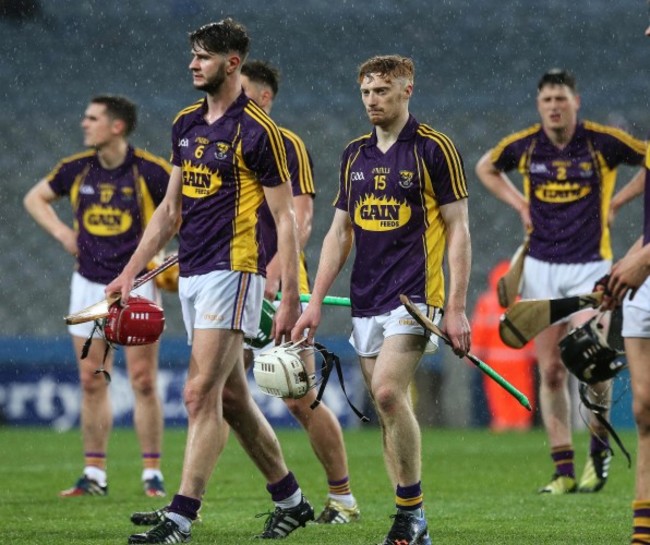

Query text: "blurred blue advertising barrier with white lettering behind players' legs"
[0, 337, 364, 430]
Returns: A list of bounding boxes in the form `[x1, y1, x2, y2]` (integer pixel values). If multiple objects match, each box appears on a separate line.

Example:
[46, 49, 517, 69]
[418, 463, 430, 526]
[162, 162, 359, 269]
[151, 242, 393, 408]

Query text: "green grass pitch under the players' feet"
[0, 427, 635, 545]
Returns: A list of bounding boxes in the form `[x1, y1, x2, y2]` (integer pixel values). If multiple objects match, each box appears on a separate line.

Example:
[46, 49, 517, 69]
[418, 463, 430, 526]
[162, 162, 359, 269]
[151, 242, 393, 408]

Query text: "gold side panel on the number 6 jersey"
[230, 139, 264, 273]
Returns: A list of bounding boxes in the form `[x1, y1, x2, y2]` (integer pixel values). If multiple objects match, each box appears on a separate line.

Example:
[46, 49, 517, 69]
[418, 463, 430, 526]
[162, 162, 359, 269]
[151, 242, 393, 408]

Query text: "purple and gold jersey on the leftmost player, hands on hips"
[46, 147, 171, 284]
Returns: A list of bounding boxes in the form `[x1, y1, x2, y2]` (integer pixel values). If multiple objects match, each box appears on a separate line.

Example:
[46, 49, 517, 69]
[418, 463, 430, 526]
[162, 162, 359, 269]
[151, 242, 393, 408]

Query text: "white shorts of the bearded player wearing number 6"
[178, 271, 265, 344]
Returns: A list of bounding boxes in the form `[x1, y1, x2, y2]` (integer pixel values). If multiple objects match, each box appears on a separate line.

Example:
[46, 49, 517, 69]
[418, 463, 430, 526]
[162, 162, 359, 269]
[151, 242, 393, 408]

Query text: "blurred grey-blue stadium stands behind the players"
[0, 0, 650, 427]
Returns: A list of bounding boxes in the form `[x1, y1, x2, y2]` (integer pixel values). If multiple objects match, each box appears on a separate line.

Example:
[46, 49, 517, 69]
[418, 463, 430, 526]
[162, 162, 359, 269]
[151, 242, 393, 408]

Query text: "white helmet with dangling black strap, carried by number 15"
[253, 339, 316, 399]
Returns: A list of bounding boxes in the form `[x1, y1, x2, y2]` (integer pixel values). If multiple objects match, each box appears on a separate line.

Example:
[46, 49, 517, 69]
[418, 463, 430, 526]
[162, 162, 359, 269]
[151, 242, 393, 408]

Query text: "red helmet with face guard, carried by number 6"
[104, 295, 165, 346]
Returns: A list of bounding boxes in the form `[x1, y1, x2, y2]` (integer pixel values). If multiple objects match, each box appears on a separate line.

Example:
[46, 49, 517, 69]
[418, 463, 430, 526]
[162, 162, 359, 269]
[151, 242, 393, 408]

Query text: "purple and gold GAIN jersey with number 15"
[334, 116, 467, 317]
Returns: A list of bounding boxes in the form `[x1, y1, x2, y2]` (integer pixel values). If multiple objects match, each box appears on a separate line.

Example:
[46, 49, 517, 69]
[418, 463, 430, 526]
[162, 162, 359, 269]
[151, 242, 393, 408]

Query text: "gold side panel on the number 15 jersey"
[413, 153, 446, 308]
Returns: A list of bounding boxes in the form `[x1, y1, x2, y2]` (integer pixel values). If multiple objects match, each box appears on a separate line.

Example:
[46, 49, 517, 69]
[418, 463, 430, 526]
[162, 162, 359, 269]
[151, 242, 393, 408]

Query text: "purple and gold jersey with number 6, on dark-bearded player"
[172, 92, 289, 276]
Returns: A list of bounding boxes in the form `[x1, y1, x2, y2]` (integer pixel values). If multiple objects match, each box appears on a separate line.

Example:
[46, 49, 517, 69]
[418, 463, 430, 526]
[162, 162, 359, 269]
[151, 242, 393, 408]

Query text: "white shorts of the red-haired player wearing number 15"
[350, 303, 442, 358]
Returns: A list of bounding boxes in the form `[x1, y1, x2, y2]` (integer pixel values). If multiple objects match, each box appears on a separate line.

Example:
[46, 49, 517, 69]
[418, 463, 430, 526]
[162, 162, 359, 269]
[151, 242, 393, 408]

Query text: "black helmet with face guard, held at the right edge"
[559, 316, 627, 384]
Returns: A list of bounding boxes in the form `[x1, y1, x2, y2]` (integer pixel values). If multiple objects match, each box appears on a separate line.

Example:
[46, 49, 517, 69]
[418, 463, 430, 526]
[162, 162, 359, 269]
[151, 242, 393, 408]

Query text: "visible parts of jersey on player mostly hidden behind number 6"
[259, 127, 316, 293]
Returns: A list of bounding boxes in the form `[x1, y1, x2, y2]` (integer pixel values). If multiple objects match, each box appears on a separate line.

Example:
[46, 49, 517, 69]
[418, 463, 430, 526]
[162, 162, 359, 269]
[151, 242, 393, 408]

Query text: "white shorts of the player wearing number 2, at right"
[521, 256, 612, 299]
